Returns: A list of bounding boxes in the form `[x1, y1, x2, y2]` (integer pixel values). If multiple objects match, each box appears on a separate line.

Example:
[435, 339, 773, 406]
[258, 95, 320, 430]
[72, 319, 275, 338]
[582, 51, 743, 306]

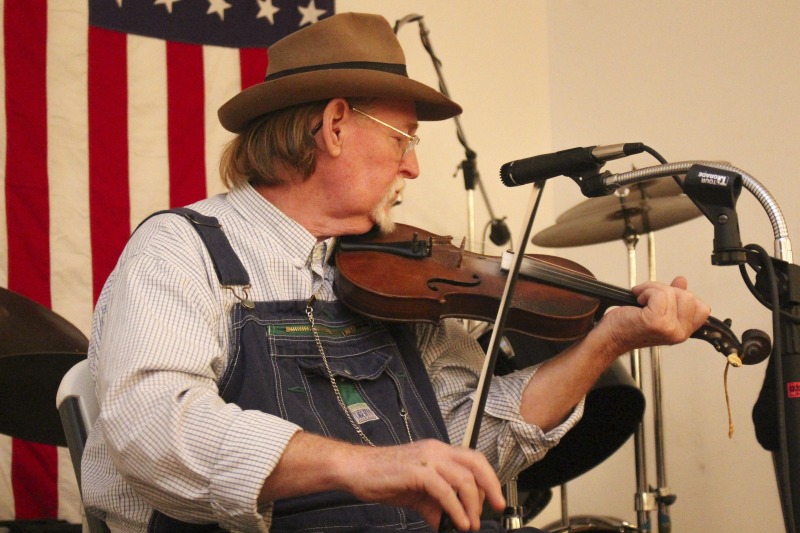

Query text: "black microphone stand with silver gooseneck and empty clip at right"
[579, 161, 800, 533]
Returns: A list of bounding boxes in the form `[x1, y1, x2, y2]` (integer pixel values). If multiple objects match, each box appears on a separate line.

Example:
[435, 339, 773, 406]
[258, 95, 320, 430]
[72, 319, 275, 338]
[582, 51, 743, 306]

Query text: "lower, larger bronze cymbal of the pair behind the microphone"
[531, 195, 702, 248]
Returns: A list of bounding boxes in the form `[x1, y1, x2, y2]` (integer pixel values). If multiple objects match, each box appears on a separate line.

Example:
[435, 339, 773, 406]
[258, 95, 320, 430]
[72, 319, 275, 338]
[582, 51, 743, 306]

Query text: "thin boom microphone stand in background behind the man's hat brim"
[394, 14, 511, 246]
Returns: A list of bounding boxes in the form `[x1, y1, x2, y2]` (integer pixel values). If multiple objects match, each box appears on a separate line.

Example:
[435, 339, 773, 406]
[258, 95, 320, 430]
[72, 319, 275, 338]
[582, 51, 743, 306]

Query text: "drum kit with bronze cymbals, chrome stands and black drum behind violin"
[488, 172, 702, 533]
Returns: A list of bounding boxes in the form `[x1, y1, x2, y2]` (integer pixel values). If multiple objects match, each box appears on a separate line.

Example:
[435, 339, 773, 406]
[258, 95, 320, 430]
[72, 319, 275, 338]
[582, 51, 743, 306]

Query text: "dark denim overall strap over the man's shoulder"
[134, 207, 250, 286]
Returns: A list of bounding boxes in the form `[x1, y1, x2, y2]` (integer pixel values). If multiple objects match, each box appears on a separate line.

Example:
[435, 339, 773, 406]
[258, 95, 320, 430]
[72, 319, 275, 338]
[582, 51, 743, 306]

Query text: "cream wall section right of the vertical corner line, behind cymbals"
[547, 1, 800, 532]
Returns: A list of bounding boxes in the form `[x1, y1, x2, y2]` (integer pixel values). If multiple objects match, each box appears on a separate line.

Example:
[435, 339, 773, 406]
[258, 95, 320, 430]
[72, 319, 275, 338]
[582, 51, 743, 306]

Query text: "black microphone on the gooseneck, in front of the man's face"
[500, 143, 644, 187]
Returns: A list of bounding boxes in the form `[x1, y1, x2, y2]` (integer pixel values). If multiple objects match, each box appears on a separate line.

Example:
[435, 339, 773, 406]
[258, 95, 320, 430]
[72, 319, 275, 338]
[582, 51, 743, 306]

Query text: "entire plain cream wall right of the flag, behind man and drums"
[344, 0, 800, 533]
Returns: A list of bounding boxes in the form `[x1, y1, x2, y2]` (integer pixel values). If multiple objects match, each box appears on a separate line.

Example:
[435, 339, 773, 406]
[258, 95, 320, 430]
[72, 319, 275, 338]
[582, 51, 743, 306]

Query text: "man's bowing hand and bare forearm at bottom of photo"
[261, 432, 505, 531]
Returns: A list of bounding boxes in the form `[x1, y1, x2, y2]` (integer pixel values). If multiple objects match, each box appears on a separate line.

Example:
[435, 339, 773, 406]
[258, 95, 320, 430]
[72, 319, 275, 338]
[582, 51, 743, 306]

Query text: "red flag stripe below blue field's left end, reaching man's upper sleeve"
[88, 26, 130, 300]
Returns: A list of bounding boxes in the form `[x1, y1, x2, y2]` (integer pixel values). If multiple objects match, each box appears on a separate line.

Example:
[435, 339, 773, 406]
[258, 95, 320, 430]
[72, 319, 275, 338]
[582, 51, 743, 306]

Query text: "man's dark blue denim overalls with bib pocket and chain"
[148, 209, 478, 533]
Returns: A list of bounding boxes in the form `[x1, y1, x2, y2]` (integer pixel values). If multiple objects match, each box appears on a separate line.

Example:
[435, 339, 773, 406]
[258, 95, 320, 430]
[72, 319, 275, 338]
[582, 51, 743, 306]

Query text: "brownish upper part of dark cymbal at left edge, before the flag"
[0, 287, 89, 356]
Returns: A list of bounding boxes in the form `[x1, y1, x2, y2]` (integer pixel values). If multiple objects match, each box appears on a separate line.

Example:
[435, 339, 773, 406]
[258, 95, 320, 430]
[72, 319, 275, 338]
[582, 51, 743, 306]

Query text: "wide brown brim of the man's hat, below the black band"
[218, 69, 462, 133]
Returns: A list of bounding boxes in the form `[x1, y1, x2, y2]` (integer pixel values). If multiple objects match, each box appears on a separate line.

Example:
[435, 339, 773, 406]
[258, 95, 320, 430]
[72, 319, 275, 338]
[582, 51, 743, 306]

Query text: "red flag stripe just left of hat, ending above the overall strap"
[167, 42, 206, 207]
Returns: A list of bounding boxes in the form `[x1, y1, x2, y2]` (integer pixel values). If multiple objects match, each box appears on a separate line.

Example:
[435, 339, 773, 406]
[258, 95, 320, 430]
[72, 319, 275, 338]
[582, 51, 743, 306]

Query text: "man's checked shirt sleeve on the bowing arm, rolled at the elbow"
[85, 217, 299, 530]
